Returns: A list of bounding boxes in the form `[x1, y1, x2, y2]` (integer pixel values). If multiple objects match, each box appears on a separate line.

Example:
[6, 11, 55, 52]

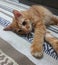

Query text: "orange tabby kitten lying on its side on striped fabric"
[4, 5, 58, 57]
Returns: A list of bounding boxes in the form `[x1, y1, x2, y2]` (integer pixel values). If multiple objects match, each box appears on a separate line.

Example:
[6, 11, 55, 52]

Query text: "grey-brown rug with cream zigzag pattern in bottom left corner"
[0, 38, 35, 65]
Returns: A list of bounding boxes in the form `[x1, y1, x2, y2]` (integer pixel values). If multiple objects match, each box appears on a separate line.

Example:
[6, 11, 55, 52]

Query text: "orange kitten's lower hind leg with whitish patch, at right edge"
[45, 32, 58, 54]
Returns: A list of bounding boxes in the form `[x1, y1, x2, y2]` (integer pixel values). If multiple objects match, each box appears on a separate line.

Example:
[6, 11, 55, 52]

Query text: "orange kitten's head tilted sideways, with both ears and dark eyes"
[4, 10, 32, 34]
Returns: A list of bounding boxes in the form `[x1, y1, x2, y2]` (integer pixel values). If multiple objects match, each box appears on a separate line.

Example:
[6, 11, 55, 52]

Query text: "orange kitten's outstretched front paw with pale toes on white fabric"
[31, 44, 43, 58]
